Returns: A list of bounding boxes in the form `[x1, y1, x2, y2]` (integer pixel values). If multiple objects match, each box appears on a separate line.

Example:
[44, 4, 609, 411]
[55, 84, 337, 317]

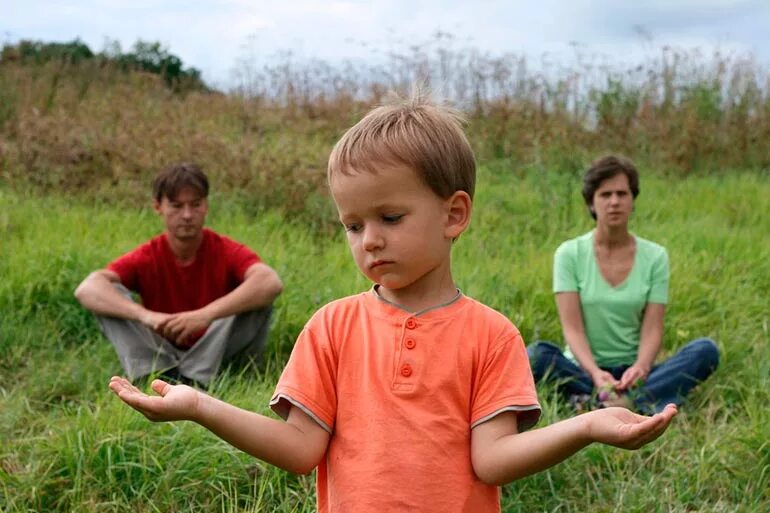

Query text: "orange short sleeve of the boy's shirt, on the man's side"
[270, 320, 337, 433]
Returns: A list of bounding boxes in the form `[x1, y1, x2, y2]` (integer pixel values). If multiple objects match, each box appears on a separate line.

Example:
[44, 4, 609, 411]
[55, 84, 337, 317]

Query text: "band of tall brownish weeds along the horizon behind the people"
[0, 38, 770, 227]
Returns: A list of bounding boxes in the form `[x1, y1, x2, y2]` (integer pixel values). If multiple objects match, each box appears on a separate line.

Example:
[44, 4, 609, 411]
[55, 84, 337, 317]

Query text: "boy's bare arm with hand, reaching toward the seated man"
[110, 377, 329, 474]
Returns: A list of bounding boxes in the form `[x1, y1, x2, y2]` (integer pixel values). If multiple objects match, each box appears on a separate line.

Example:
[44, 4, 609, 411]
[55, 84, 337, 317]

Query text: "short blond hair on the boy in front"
[327, 91, 476, 199]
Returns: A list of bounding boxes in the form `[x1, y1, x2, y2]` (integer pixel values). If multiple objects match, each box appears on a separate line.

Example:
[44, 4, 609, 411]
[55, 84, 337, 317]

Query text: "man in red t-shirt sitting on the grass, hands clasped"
[75, 164, 283, 387]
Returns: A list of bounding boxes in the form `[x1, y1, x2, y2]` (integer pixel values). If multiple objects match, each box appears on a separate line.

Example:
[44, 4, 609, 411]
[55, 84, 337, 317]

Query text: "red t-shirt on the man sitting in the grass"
[107, 228, 262, 336]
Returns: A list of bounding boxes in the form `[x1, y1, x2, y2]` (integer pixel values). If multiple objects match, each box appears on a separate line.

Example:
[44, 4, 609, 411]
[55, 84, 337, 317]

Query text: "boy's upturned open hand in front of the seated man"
[110, 376, 202, 422]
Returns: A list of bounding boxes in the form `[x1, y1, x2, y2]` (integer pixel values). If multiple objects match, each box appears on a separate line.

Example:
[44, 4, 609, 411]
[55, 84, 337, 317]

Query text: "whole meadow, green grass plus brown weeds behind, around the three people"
[0, 41, 770, 513]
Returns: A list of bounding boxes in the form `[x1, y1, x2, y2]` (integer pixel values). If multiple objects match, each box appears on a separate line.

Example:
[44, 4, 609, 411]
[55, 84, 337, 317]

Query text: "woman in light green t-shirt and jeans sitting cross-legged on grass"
[527, 155, 719, 413]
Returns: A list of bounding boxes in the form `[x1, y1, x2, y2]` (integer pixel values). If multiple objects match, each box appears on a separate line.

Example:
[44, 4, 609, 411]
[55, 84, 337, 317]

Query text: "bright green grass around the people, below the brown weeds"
[0, 165, 770, 513]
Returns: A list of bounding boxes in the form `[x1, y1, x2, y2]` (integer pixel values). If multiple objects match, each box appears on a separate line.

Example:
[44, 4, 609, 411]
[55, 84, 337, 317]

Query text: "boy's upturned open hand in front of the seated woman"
[582, 404, 677, 449]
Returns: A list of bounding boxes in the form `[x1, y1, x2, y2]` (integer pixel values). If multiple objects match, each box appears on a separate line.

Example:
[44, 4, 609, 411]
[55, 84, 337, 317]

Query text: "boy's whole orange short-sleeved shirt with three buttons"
[270, 291, 540, 513]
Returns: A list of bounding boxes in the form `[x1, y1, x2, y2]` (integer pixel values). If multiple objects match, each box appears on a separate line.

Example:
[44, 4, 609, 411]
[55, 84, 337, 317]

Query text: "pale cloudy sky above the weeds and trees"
[6, 0, 770, 87]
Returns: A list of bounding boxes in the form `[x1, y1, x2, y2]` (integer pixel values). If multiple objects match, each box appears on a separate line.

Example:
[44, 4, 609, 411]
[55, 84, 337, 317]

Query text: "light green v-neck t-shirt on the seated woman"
[553, 230, 669, 367]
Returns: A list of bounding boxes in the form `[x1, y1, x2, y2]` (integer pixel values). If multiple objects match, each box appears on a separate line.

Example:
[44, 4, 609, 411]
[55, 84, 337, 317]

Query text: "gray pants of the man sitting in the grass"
[96, 284, 273, 385]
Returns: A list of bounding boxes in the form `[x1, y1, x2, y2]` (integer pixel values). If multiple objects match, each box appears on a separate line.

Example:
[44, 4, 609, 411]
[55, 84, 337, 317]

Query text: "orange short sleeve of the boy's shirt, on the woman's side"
[471, 326, 540, 431]
